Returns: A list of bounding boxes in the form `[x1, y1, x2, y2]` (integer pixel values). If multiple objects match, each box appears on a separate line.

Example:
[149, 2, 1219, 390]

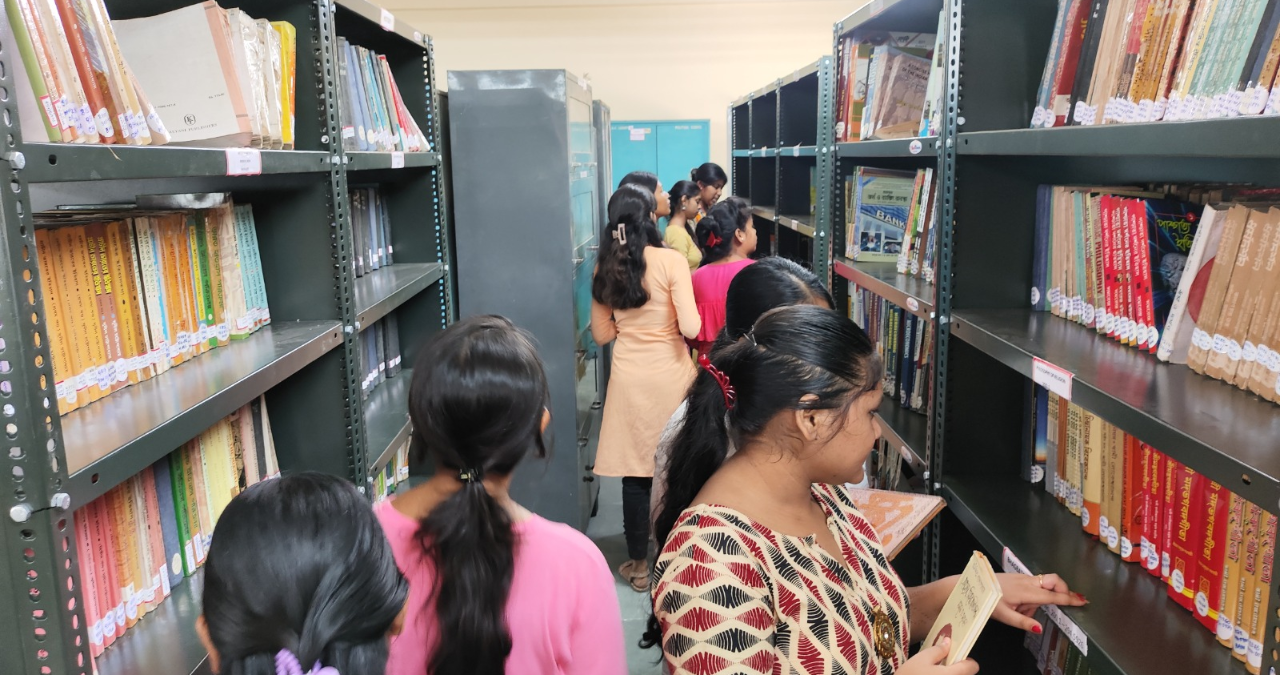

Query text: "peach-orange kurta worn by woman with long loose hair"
[591, 246, 701, 476]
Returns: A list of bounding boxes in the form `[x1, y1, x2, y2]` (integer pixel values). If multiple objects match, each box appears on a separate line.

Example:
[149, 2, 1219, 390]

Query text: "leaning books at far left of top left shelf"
[5, 0, 170, 145]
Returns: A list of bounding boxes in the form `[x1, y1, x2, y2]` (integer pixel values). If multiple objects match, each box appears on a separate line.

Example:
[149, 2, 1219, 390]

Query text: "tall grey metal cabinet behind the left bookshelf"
[449, 70, 608, 529]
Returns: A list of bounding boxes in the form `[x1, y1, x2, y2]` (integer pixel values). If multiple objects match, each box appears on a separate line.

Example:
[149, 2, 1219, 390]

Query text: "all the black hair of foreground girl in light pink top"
[409, 316, 550, 675]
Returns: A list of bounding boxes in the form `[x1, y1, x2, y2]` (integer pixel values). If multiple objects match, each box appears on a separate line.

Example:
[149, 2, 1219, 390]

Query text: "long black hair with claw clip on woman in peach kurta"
[591, 184, 662, 310]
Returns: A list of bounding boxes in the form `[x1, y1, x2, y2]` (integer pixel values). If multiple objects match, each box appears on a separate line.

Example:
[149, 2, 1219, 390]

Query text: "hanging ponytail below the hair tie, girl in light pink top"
[417, 480, 516, 675]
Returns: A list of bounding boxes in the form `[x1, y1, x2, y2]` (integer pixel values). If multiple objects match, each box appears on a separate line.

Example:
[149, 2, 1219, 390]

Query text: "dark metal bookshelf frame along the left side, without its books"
[0, 0, 454, 675]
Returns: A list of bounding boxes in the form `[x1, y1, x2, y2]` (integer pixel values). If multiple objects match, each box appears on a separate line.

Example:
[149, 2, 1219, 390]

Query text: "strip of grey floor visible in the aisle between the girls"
[586, 478, 662, 675]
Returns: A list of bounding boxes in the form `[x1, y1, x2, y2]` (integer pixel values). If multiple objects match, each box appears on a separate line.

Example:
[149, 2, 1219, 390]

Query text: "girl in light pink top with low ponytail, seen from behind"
[373, 316, 626, 675]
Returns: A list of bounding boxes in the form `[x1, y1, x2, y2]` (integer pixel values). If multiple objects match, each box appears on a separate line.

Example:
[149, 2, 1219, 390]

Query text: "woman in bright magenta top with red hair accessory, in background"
[692, 197, 756, 356]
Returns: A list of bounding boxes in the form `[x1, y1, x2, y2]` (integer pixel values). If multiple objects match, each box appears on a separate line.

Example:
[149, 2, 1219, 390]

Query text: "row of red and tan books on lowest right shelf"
[1028, 387, 1276, 674]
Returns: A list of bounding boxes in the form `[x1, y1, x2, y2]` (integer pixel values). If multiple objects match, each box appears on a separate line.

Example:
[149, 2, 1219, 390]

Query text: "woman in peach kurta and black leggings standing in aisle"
[591, 184, 701, 592]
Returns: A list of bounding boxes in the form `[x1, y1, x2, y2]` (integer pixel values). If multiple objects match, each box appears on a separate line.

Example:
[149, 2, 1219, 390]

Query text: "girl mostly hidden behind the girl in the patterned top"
[649, 256, 836, 523]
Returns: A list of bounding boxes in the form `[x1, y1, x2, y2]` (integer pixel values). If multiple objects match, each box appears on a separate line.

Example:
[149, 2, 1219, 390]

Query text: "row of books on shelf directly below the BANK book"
[849, 283, 933, 412]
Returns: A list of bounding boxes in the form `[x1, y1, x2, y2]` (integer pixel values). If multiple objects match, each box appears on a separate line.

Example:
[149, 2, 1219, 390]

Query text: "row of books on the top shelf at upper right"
[1032, 0, 1280, 127]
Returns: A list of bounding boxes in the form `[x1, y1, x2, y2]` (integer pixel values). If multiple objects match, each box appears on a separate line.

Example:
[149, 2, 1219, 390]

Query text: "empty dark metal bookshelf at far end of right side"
[728, 56, 836, 278]
